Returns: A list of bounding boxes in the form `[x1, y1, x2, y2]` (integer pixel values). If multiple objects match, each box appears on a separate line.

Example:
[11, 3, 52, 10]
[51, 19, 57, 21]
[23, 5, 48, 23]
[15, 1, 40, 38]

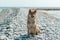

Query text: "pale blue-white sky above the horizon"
[0, 0, 60, 7]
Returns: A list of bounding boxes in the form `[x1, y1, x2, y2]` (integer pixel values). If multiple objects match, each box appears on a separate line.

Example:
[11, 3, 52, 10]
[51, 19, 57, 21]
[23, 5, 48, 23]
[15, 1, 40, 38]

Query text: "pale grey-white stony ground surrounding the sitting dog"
[0, 8, 60, 40]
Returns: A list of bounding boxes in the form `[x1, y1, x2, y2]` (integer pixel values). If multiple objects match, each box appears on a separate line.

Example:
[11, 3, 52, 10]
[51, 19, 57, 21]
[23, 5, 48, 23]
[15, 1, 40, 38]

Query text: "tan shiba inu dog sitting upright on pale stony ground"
[27, 9, 41, 36]
